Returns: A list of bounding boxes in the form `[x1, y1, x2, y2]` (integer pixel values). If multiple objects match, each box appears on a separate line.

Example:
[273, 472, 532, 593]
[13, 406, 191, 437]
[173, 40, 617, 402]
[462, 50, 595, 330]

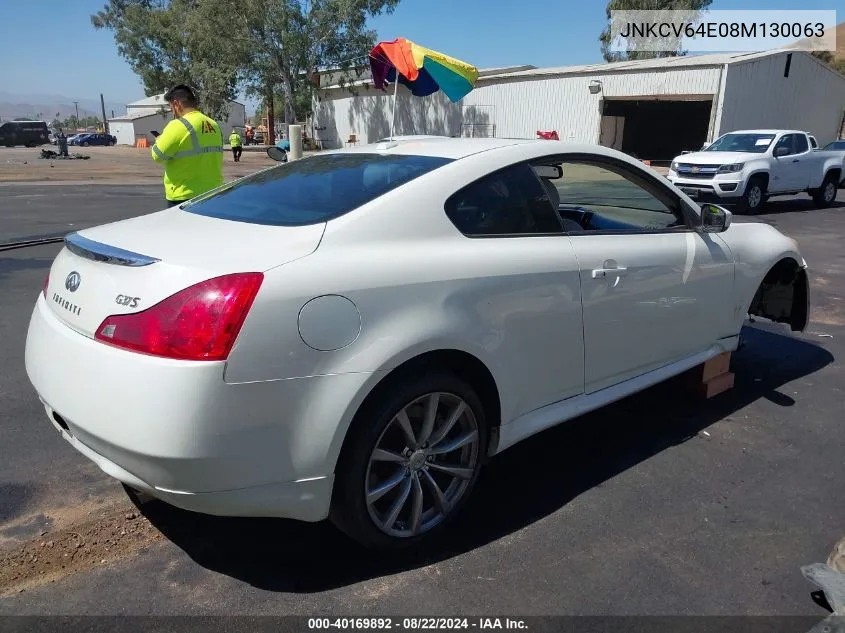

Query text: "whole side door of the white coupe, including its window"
[532, 155, 736, 393]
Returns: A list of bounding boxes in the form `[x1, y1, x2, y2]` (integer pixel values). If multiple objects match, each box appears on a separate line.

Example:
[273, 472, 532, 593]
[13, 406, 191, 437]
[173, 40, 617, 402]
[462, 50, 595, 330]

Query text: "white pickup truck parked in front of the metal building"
[668, 130, 845, 214]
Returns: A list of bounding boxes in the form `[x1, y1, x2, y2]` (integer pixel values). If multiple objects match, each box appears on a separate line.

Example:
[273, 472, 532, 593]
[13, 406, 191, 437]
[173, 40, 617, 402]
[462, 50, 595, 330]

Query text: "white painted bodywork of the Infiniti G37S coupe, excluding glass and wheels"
[26, 138, 803, 521]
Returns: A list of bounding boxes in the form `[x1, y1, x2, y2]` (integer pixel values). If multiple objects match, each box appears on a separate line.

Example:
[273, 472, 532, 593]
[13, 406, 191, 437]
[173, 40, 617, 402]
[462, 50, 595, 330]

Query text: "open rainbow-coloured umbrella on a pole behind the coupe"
[370, 37, 478, 138]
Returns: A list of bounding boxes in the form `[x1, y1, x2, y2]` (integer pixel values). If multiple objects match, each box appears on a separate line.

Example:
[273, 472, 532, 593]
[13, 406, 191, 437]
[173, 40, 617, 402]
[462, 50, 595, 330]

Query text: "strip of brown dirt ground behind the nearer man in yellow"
[0, 145, 284, 185]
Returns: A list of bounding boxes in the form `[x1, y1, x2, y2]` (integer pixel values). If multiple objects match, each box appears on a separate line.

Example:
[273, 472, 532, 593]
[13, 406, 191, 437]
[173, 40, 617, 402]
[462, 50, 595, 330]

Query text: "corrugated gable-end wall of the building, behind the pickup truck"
[718, 52, 845, 145]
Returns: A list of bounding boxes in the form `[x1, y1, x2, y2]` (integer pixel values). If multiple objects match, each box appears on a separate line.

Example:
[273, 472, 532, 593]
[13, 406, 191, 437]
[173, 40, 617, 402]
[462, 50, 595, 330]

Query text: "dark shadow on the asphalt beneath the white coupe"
[141, 327, 833, 592]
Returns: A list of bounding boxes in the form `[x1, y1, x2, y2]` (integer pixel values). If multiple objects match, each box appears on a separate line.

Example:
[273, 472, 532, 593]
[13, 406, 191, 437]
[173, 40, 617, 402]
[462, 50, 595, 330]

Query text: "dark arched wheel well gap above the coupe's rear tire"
[350, 349, 502, 453]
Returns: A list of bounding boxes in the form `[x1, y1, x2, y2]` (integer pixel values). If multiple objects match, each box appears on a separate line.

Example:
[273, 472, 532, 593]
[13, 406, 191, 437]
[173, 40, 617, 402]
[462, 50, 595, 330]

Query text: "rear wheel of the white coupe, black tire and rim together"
[330, 370, 487, 550]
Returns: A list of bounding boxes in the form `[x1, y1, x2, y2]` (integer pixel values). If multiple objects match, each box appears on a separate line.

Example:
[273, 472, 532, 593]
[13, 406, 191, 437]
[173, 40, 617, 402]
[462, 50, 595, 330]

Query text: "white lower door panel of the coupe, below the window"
[572, 232, 736, 393]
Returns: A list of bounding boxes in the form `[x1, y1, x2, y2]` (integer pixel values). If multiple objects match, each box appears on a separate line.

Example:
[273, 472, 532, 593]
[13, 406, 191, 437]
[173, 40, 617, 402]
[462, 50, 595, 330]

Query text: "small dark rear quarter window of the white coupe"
[446, 164, 563, 236]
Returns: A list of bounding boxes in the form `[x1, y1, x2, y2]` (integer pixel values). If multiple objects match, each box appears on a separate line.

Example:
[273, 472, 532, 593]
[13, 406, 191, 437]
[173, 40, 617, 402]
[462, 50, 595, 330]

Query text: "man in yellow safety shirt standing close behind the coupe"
[152, 84, 223, 207]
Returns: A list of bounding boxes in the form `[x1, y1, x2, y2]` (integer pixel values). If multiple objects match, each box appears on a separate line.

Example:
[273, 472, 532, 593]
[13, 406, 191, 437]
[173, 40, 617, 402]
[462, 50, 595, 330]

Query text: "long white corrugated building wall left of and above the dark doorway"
[315, 67, 719, 147]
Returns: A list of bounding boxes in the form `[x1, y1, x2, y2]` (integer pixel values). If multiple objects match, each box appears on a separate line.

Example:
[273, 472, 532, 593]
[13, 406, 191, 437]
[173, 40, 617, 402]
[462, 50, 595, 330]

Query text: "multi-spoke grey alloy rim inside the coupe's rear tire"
[364, 392, 481, 538]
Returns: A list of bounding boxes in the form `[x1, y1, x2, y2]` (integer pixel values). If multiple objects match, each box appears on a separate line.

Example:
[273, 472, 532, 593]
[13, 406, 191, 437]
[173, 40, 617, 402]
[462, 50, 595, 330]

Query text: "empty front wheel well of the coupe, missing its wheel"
[748, 257, 810, 332]
